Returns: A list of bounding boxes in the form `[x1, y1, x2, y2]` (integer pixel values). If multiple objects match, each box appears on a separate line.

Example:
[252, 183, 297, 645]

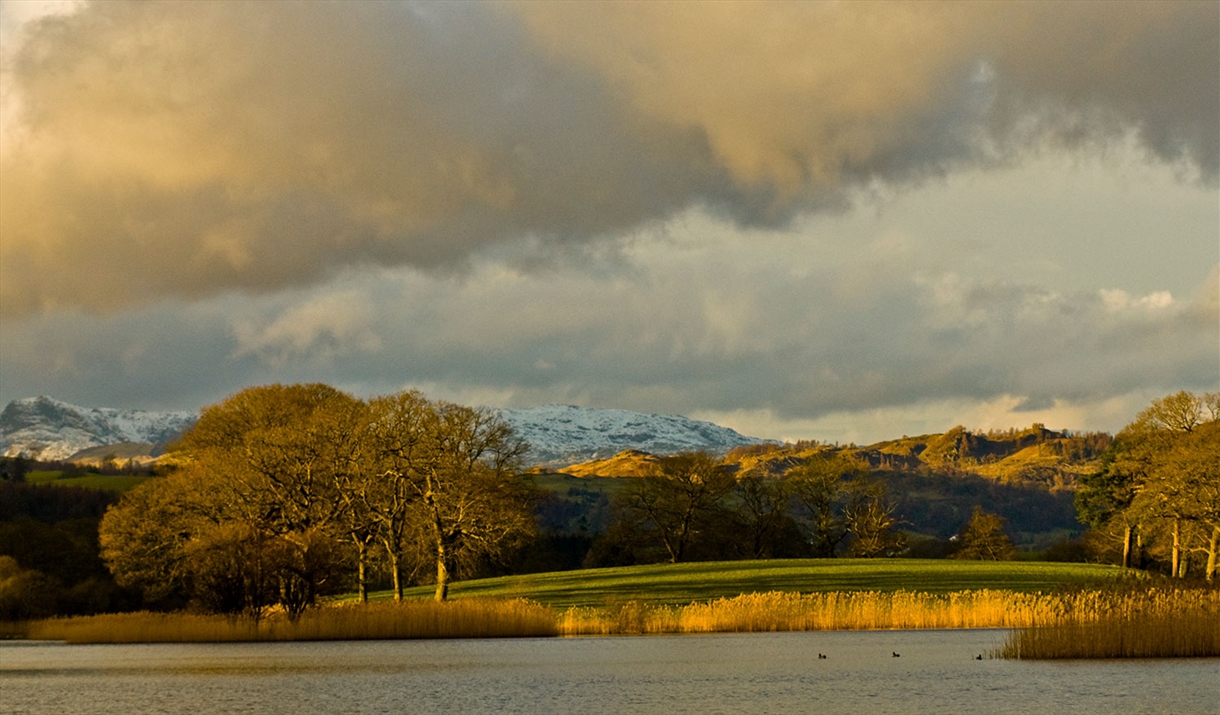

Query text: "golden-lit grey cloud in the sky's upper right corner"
[514, 2, 1220, 186]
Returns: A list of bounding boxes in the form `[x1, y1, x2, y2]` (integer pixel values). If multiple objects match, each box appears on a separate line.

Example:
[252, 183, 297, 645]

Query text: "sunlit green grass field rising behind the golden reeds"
[371, 559, 1122, 609]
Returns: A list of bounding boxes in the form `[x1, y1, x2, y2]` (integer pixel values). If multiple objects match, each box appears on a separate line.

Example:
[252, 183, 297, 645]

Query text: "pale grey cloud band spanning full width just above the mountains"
[0, 200, 1220, 442]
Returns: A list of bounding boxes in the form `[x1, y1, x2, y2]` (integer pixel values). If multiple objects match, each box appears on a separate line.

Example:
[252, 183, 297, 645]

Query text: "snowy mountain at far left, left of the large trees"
[0, 397, 199, 460]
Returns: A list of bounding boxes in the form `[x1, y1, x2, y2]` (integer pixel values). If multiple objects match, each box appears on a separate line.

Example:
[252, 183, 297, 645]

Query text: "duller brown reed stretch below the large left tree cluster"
[28, 599, 558, 643]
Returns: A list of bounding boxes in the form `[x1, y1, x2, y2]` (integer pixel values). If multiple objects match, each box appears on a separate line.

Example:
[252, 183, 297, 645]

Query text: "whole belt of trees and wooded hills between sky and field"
[0, 384, 1220, 620]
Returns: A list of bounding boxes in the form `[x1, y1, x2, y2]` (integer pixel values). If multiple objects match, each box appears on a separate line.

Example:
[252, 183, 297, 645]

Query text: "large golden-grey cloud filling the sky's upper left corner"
[0, 2, 716, 315]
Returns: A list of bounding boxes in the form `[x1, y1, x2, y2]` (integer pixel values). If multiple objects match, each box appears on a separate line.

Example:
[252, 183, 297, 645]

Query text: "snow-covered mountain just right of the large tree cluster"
[500, 405, 766, 466]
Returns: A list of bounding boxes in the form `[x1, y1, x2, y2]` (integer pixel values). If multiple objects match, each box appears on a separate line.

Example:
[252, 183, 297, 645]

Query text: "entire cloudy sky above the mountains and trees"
[0, 0, 1220, 443]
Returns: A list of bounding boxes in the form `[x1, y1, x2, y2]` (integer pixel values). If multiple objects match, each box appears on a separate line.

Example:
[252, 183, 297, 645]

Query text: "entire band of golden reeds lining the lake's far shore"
[19, 588, 1220, 658]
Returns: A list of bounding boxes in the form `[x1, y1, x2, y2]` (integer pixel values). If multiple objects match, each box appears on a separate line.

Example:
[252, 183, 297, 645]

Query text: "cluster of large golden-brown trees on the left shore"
[100, 384, 533, 615]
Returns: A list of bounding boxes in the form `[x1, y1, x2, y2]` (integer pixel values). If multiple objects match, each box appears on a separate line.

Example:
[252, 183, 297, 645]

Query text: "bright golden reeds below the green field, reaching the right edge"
[558, 589, 1220, 644]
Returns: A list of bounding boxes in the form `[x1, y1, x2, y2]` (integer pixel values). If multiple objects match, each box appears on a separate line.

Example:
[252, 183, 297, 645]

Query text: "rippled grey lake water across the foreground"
[0, 631, 1220, 715]
